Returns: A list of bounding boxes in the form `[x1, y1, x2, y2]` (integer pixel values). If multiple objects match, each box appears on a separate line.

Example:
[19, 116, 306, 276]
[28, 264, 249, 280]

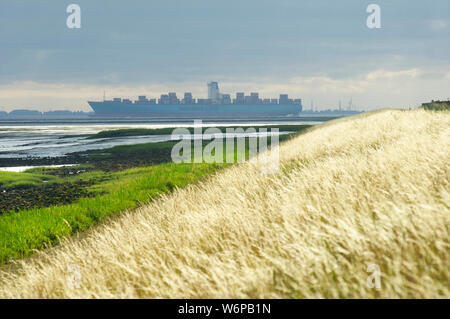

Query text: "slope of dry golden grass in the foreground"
[0, 110, 450, 298]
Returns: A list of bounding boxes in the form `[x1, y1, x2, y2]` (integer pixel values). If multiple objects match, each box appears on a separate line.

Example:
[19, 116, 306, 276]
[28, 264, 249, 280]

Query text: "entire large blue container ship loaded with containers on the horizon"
[88, 82, 302, 119]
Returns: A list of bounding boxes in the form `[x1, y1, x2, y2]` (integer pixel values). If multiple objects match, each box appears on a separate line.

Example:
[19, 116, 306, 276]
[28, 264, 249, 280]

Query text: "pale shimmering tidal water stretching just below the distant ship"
[0, 118, 323, 169]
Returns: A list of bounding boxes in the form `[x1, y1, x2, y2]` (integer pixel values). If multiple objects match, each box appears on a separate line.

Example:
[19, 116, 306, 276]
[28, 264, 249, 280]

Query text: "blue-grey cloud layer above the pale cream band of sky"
[0, 0, 449, 85]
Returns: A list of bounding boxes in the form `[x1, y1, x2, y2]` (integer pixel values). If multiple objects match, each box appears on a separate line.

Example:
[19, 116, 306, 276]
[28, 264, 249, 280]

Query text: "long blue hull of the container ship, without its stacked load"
[88, 102, 302, 119]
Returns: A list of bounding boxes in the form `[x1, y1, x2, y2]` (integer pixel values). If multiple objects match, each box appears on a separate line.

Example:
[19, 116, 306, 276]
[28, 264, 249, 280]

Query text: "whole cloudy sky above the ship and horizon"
[0, 0, 450, 111]
